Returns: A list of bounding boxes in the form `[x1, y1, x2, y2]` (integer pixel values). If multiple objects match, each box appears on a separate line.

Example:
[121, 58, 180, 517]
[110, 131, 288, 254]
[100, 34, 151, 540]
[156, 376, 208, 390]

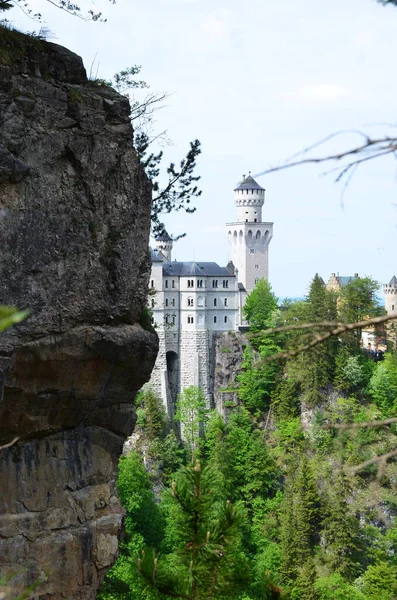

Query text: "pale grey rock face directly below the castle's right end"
[214, 331, 247, 416]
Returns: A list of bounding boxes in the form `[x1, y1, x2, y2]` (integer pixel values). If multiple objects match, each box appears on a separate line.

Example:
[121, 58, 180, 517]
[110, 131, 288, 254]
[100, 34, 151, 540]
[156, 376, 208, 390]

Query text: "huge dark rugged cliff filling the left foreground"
[0, 29, 157, 600]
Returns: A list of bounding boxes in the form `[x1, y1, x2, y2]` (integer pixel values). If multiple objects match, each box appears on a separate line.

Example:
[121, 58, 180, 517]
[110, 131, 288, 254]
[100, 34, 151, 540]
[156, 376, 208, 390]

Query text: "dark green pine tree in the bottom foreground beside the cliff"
[139, 461, 248, 600]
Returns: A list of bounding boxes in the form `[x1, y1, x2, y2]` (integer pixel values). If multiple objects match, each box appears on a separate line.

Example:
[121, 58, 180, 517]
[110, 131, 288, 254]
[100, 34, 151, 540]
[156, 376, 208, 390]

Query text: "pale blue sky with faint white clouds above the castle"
[7, 0, 397, 297]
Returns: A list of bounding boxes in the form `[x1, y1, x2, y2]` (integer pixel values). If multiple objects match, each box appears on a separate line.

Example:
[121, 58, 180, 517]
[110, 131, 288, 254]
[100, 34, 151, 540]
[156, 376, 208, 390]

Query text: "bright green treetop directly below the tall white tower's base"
[243, 279, 277, 331]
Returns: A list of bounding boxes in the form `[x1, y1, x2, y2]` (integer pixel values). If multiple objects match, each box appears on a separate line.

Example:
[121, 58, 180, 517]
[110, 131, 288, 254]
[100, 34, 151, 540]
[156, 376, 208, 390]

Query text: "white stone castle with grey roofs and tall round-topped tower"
[149, 175, 273, 416]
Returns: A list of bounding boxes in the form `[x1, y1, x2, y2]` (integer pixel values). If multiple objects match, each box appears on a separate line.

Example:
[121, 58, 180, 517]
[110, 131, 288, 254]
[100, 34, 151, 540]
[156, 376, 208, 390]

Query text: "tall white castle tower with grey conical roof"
[226, 174, 273, 293]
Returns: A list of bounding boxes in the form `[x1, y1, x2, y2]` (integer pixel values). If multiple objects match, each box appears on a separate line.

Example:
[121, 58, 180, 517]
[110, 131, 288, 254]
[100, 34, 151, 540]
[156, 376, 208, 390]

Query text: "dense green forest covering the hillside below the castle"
[97, 275, 397, 600]
